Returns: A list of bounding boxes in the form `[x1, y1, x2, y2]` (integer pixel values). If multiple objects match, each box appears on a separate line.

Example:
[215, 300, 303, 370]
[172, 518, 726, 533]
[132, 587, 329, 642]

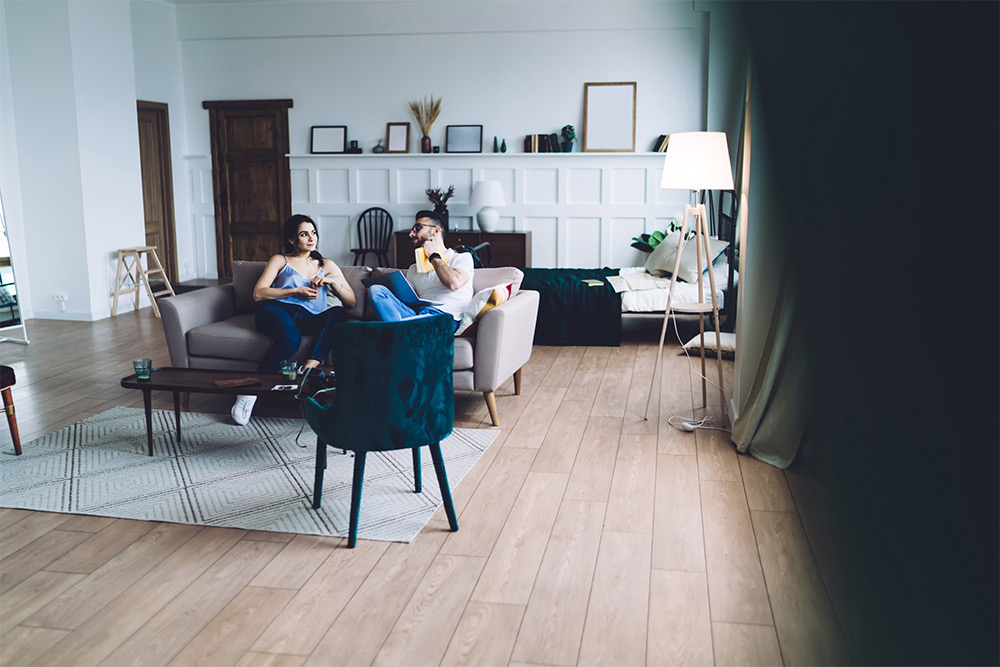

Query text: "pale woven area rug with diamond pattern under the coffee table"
[0, 407, 499, 542]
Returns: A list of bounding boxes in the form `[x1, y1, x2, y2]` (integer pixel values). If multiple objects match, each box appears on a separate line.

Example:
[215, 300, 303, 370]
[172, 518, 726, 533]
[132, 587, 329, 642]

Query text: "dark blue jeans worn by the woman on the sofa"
[255, 301, 347, 373]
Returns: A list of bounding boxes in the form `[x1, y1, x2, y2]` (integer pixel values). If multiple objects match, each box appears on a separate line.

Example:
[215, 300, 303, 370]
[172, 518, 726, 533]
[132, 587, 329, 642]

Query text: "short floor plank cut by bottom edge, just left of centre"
[441, 602, 524, 667]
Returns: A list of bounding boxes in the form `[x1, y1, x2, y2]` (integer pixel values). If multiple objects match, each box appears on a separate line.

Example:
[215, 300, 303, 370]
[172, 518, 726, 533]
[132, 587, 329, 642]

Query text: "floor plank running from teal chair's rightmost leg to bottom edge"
[306, 531, 445, 667]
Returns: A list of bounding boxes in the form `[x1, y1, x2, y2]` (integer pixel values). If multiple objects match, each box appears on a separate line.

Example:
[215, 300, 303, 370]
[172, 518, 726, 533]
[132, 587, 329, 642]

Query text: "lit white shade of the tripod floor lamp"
[664, 132, 733, 196]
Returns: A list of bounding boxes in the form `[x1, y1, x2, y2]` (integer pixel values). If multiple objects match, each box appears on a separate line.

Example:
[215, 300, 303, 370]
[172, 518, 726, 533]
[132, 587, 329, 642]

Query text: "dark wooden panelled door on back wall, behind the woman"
[202, 100, 292, 277]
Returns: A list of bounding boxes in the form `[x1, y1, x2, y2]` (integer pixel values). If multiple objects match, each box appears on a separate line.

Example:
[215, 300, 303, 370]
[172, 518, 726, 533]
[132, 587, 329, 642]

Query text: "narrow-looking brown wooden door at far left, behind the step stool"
[136, 100, 177, 283]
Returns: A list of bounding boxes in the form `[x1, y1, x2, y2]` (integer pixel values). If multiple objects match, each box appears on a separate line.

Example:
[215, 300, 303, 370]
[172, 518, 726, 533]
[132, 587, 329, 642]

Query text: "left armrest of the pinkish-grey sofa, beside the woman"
[156, 285, 236, 368]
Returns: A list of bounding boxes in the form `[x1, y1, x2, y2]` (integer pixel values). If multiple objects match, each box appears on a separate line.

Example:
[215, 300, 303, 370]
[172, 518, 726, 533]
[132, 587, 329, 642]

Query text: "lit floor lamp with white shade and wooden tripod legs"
[643, 132, 733, 419]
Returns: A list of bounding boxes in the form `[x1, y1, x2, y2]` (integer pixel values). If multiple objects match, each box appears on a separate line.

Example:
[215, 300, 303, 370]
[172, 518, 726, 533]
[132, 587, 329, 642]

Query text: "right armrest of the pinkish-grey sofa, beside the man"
[473, 290, 538, 391]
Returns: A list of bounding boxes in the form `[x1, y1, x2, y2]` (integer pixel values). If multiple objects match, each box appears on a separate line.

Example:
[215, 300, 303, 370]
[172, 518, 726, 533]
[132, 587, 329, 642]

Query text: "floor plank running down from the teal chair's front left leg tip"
[250, 540, 389, 656]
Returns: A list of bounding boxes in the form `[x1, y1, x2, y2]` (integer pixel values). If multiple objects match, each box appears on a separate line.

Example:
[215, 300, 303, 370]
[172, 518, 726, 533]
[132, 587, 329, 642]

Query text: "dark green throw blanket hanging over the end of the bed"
[521, 267, 622, 347]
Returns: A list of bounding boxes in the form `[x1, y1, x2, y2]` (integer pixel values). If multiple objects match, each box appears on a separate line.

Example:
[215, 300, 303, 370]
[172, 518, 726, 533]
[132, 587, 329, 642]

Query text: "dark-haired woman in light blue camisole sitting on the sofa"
[232, 215, 357, 425]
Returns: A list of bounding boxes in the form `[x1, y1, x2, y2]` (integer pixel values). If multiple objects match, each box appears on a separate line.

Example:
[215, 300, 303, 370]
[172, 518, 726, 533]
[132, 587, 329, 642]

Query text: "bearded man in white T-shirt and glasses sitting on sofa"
[368, 211, 473, 329]
